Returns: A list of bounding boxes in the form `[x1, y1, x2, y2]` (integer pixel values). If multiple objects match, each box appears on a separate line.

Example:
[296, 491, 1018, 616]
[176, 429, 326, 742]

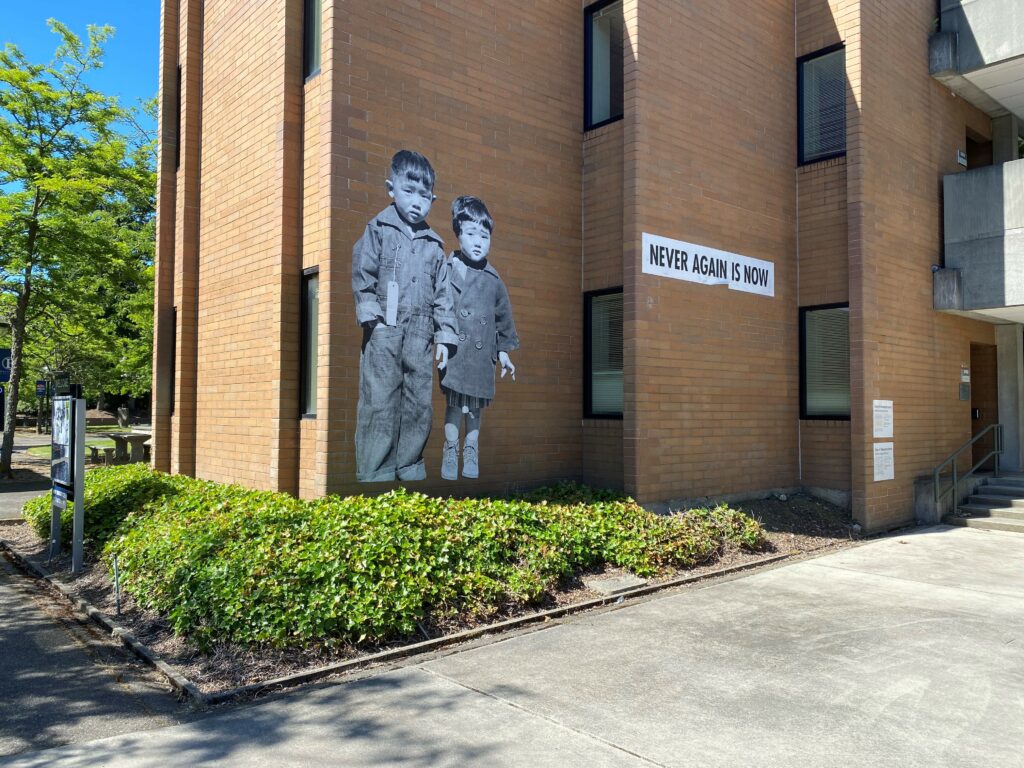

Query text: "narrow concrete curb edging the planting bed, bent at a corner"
[0, 539, 813, 708]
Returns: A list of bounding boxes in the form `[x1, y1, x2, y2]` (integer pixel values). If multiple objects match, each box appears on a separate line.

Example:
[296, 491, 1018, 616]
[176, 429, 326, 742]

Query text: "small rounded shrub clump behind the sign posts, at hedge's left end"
[22, 464, 187, 549]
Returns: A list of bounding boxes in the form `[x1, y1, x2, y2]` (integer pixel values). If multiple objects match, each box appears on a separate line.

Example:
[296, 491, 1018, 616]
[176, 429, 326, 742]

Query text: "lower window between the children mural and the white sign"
[584, 288, 623, 419]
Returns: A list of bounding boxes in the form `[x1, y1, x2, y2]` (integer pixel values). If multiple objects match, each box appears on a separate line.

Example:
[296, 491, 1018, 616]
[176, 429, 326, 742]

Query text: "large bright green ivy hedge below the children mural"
[19, 465, 764, 646]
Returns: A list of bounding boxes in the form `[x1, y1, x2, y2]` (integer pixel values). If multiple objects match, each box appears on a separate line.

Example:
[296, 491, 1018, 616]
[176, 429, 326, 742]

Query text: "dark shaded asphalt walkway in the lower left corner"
[0, 557, 182, 755]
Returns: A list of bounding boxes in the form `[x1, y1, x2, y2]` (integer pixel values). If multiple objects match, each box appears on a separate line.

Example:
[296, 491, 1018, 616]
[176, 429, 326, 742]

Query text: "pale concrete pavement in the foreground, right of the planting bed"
[0, 527, 1024, 768]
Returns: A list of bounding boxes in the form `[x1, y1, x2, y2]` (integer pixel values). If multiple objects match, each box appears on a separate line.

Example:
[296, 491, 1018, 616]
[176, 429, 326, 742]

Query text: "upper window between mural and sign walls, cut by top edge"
[584, 0, 624, 130]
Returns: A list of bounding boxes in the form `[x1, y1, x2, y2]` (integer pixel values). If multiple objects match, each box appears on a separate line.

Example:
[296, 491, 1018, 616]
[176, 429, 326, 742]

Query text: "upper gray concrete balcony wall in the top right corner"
[941, 0, 1024, 73]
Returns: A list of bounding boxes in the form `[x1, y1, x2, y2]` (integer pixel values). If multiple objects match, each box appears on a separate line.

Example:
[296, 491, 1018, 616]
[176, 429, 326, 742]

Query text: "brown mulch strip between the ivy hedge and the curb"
[0, 494, 855, 693]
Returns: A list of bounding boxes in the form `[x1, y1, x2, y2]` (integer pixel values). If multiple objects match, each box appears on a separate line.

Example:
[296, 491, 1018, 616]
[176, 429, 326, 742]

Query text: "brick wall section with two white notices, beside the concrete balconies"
[848, 0, 993, 529]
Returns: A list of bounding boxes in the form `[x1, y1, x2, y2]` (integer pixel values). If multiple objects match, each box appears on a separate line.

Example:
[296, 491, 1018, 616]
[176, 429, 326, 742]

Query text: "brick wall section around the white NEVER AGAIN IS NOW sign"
[625, 0, 799, 501]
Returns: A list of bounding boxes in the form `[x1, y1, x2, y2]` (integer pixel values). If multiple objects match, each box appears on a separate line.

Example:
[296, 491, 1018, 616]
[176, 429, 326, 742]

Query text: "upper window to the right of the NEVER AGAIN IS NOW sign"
[797, 47, 846, 165]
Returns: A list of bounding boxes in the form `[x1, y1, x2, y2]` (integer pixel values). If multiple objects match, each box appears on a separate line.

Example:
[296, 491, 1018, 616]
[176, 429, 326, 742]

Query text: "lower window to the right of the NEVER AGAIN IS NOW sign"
[800, 304, 850, 419]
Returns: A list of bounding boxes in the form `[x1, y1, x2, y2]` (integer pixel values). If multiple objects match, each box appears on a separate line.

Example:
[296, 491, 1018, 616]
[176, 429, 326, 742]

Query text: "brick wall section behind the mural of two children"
[321, 0, 583, 493]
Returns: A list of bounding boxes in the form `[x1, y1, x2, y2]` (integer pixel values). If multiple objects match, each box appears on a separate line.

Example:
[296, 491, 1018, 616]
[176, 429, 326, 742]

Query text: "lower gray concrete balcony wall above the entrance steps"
[943, 160, 1024, 309]
